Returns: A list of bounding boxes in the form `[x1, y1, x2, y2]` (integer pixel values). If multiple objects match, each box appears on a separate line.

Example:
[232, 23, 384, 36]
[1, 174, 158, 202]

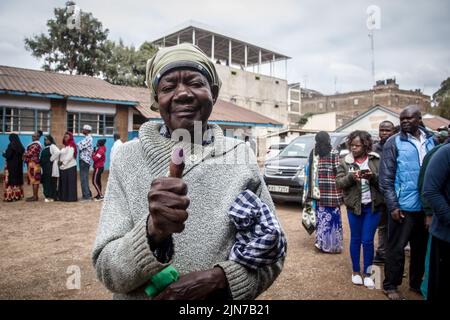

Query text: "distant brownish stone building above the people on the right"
[301, 79, 431, 127]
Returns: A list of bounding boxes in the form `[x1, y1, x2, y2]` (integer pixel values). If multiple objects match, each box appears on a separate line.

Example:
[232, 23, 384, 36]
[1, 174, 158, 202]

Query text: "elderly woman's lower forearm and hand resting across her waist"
[154, 267, 228, 300]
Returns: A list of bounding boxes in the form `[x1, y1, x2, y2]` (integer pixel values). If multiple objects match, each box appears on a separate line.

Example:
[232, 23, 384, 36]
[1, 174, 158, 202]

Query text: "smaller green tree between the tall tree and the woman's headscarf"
[104, 40, 156, 87]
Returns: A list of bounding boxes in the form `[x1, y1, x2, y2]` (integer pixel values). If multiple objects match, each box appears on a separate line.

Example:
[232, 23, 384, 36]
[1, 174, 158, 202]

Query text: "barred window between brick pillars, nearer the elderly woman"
[67, 112, 114, 136]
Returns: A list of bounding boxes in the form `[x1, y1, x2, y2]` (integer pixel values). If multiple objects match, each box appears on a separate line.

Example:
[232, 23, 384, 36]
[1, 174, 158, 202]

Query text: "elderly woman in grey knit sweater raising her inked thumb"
[93, 43, 286, 300]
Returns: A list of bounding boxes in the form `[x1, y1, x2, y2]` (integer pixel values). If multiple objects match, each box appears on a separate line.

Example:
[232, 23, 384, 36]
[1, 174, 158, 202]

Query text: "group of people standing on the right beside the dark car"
[302, 106, 450, 300]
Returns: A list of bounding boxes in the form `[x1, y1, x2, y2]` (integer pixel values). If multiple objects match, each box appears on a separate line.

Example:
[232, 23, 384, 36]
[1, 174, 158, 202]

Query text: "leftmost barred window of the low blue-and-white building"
[0, 107, 50, 134]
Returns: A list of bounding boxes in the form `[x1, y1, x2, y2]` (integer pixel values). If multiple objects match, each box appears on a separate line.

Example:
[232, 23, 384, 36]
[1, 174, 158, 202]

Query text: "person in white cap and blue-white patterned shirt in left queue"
[77, 124, 94, 201]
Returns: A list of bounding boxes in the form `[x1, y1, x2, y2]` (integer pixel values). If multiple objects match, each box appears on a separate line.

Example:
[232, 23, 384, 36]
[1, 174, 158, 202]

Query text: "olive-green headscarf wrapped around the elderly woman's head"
[145, 43, 222, 111]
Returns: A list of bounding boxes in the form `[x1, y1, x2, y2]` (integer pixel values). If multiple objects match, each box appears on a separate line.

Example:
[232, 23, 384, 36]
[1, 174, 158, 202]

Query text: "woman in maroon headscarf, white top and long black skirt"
[58, 131, 78, 201]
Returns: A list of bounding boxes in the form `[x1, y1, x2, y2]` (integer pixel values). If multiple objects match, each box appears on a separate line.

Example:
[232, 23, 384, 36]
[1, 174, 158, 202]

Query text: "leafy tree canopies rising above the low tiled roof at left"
[25, 1, 156, 86]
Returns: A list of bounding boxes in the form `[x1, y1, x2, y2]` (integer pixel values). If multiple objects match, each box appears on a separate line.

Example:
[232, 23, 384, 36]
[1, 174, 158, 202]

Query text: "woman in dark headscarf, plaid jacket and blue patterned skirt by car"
[302, 131, 343, 253]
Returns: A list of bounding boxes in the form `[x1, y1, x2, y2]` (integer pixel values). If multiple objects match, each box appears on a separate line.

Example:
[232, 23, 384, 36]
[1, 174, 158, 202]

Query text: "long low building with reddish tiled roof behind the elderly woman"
[0, 66, 282, 170]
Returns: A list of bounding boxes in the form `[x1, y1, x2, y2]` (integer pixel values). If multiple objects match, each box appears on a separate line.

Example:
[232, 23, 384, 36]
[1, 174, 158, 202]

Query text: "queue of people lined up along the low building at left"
[3, 125, 122, 202]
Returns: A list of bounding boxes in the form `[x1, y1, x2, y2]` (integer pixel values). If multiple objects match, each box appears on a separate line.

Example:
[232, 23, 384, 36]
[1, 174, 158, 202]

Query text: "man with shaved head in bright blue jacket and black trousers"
[379, 105, 435, 300]
